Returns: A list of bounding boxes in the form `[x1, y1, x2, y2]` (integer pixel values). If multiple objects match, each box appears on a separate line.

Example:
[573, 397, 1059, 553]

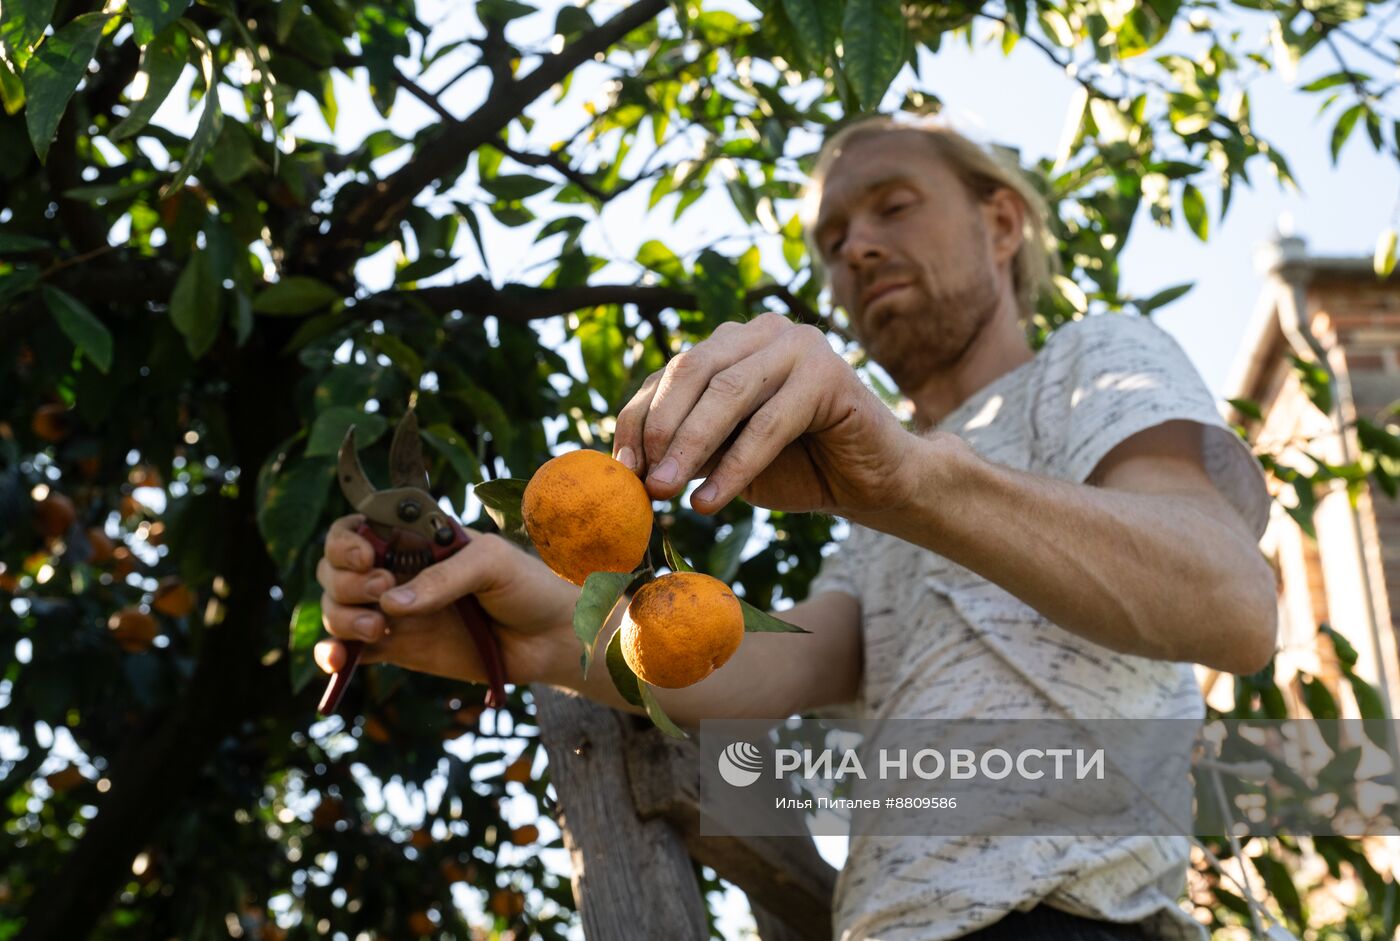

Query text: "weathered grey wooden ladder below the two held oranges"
[531, 685, 836, 941]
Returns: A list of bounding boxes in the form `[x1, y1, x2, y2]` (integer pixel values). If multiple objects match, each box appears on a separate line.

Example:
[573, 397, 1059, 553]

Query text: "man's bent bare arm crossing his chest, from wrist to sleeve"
[853, 420, 1277, 674]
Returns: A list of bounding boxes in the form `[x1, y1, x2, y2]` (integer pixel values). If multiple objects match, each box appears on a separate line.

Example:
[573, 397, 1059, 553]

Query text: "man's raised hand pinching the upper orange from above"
[613, 314, 917, 515]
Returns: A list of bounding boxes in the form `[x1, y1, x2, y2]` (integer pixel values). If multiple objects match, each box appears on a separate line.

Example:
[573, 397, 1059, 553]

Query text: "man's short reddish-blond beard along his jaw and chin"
[860, 260, 998, 389]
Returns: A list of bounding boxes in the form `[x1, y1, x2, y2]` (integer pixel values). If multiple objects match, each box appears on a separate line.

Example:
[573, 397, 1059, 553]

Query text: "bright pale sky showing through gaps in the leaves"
[13, 0, 1400, 937]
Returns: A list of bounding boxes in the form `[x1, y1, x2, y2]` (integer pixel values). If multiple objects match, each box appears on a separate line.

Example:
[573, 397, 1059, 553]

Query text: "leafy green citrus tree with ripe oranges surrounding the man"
[0, 0, 1400, 941]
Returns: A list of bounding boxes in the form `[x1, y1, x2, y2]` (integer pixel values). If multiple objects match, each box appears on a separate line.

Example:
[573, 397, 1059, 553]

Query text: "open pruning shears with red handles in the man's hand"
[316, 407, 505, 716]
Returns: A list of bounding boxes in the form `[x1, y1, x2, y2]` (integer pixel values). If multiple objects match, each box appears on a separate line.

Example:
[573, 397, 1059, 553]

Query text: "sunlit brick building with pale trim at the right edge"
[1220, 238, 1400, 717]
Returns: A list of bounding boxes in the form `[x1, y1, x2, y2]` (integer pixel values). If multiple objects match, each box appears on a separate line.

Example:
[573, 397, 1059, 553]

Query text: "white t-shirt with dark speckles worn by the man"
[811, 314, 1270, 941]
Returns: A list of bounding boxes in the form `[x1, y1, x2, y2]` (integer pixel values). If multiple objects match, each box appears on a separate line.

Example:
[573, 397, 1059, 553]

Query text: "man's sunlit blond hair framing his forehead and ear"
[801, 115, 1057, 319]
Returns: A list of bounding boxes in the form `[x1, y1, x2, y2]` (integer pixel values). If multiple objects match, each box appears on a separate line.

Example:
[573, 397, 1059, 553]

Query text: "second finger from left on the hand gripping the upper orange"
[647, 343, 799, 500]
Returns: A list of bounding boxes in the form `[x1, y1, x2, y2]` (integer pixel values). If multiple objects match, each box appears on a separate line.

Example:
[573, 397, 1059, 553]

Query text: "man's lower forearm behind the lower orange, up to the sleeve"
[540, 591, 864, 728]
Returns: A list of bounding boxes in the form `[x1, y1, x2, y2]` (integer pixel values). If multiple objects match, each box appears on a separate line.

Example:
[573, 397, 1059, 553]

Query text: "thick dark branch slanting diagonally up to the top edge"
[302, 0, 666, 276]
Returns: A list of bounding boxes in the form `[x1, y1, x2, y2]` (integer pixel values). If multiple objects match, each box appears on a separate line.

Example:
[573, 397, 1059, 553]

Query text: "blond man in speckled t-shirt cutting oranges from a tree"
[318, 119, 1275, 941]
